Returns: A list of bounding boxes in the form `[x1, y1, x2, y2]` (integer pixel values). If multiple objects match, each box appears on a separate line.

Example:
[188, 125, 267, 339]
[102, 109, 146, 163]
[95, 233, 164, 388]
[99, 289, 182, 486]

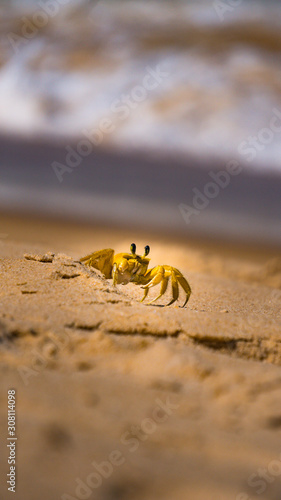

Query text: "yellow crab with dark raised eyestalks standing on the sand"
[80, 243, 191, 307]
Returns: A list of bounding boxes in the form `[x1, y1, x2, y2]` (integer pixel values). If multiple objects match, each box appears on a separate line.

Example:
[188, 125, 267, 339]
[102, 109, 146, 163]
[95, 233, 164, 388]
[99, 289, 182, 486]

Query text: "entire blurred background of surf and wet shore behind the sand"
[0, 0, 281, 247]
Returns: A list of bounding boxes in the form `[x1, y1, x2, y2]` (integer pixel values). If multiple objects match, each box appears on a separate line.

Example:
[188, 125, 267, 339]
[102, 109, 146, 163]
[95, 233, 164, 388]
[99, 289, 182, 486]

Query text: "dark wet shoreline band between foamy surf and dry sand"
[0, 137, 281, 247]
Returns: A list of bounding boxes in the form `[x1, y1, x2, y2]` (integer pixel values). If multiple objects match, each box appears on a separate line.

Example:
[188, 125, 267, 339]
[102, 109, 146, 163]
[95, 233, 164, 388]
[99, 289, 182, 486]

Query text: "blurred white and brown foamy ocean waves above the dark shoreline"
[0, 0, 281, 172]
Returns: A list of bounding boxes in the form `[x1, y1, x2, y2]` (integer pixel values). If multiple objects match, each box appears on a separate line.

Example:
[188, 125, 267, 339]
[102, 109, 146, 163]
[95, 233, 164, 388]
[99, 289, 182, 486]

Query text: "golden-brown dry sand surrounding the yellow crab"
[0, 217, 281, 500]
